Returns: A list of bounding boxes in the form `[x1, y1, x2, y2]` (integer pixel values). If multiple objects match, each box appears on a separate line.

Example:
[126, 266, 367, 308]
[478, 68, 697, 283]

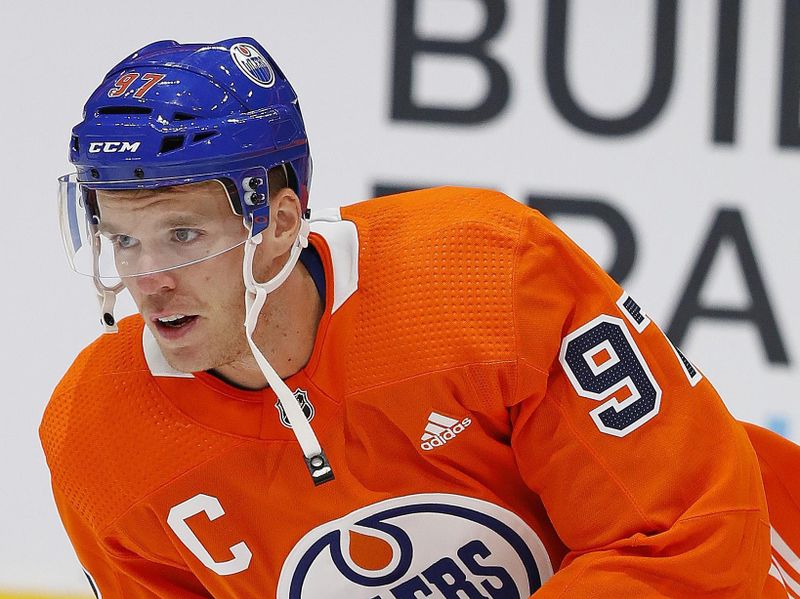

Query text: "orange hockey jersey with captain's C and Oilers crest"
[40, 188, 800, 599]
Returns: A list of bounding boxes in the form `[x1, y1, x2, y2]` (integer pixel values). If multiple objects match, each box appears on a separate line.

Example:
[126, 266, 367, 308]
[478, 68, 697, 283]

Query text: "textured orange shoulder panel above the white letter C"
[39, 316, 241, 530]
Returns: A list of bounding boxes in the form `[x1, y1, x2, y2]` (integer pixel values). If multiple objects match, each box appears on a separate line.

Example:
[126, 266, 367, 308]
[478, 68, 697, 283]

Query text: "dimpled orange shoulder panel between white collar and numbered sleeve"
[334, 187, 544, 388]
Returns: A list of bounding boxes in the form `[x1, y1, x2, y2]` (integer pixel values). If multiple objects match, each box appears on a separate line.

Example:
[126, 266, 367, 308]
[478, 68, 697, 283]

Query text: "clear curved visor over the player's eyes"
[58, 173, 249, 280]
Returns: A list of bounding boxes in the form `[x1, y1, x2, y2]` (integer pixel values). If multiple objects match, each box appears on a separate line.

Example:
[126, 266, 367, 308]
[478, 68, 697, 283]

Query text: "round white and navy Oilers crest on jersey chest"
[277, 494, 553, 599]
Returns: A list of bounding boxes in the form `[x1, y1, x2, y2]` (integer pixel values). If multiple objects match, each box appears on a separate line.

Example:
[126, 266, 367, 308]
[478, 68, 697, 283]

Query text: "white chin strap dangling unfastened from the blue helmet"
[242, 220, 333, 485]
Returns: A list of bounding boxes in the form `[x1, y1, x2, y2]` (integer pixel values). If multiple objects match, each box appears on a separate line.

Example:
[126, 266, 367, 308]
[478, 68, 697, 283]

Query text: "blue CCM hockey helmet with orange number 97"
[59, 37, 311, 277]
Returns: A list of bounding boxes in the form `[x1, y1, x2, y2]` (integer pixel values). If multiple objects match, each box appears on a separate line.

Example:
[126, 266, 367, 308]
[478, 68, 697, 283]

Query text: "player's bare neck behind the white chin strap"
[210, 262, 325, 389]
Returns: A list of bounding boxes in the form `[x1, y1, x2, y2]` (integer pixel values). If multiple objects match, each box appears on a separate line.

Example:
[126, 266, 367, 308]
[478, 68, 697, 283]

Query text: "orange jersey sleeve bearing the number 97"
[508, 212, 770, 599]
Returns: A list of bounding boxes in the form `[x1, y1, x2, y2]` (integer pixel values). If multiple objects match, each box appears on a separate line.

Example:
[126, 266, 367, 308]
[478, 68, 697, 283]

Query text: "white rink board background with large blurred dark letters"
[0, 0, 800, 597]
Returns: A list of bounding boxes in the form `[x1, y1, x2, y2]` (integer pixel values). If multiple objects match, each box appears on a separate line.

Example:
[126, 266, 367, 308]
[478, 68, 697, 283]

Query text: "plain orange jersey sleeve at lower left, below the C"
[53, 485, 211, 599]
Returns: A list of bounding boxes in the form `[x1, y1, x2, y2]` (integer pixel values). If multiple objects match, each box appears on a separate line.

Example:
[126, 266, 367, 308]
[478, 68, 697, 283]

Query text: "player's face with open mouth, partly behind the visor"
[97, 181, 256, 372]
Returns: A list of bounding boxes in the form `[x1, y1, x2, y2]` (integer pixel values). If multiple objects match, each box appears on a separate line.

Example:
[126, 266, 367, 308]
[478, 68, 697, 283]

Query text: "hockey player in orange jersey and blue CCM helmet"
[41, 38, 800, 599]
